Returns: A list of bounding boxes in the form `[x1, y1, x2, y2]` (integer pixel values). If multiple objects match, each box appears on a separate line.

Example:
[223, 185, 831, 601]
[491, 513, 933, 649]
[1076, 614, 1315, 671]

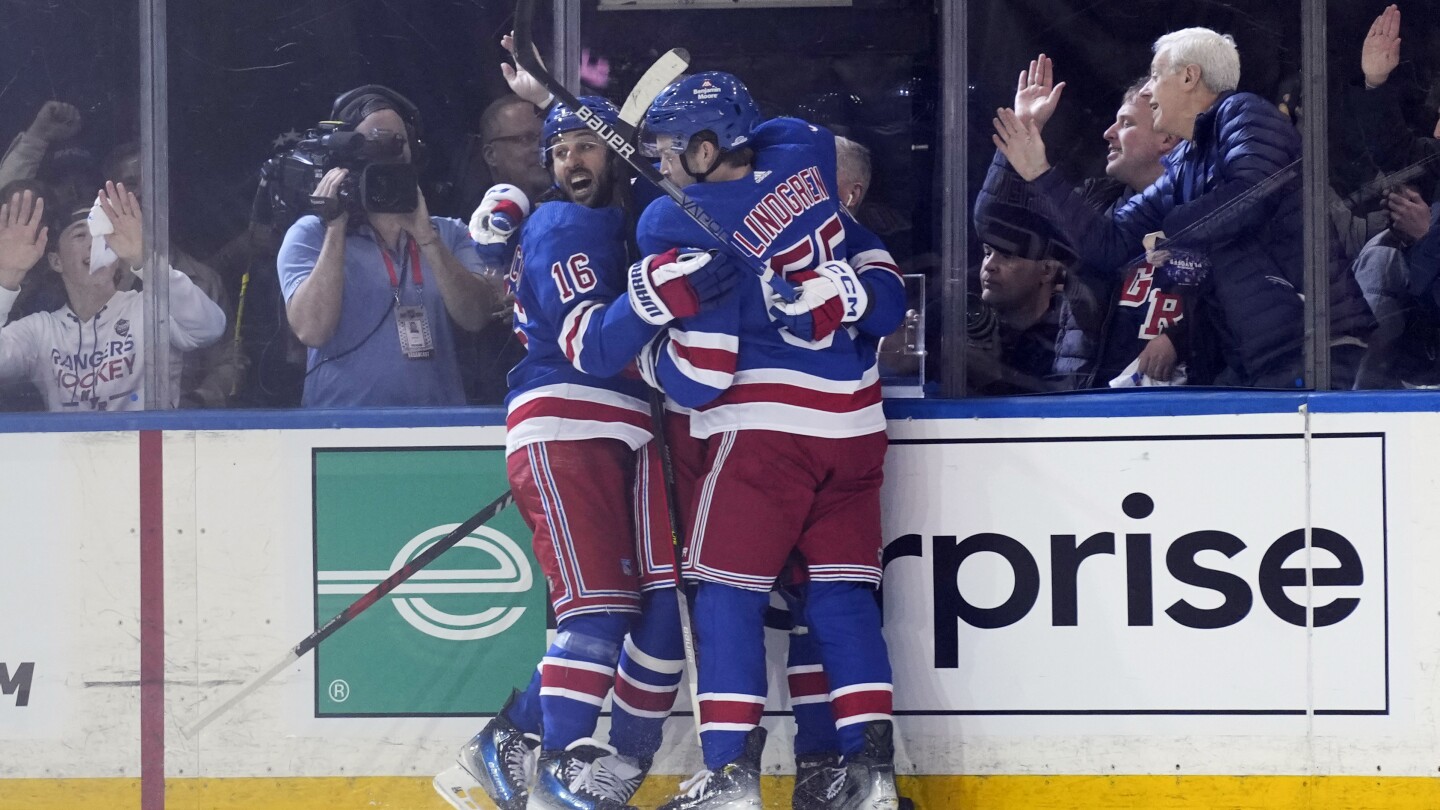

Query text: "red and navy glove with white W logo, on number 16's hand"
[629, 248, 737, 326]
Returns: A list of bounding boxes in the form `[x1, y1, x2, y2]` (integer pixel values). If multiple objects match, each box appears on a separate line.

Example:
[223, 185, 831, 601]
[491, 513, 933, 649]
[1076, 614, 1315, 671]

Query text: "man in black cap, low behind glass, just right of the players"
[966, 196, 1074, 395]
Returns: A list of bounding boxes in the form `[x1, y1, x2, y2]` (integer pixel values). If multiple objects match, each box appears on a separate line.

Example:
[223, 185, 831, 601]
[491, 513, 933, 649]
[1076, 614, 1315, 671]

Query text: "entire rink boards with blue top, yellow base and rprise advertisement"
[0, 395, 1440, 809]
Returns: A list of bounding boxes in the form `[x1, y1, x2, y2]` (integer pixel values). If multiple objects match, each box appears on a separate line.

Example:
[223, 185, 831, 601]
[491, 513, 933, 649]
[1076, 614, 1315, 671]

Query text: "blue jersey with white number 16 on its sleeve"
[505, 202, 655, 453]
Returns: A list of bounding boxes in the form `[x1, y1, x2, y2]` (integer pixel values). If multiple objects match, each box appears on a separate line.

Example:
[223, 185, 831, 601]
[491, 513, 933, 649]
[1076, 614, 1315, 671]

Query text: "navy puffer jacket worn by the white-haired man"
[1036, 92, 1374, 386]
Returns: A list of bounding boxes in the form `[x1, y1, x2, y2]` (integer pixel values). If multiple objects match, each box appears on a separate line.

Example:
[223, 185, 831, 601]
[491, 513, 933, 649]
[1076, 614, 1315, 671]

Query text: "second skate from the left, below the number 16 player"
[526, 736, 644, 810]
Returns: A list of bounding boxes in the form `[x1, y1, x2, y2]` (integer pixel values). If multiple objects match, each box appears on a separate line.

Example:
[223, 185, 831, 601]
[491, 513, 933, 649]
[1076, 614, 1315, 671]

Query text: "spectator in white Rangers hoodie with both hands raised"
[0, 184, 225, 411]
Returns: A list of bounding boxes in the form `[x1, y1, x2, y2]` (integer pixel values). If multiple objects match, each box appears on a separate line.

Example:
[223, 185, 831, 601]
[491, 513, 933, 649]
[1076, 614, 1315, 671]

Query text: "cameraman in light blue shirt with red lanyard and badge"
[276, 85, 503, 408]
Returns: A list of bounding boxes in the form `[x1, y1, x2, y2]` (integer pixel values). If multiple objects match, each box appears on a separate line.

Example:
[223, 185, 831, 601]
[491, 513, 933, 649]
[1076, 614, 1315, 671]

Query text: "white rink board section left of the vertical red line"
[0, 432, 140, 778]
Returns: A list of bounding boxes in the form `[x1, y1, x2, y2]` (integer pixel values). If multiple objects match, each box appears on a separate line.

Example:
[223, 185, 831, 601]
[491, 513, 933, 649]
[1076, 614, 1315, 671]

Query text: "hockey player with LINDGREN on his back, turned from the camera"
[638, 74, 904, 810]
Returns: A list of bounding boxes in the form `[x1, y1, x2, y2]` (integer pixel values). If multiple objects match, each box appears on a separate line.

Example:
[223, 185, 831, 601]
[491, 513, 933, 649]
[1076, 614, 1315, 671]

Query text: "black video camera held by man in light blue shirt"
[261, 121, 420, 228]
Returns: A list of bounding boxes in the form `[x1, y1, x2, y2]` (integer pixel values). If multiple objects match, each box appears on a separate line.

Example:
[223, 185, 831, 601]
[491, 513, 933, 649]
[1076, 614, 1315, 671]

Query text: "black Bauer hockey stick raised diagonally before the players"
[514, 0, 796, 303]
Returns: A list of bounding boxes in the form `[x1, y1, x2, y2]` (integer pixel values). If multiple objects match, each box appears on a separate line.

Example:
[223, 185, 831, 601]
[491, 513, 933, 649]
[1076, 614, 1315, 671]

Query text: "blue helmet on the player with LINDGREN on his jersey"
[641, 71, 760, 157]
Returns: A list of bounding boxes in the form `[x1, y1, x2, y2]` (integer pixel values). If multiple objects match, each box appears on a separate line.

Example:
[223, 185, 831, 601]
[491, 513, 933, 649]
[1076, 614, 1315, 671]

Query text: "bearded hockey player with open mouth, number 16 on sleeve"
[437, 97, 726, 810]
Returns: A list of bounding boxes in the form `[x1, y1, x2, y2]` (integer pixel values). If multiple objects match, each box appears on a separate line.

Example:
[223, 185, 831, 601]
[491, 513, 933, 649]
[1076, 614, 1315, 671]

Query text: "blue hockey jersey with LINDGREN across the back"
[638, 118, 904, 438]
